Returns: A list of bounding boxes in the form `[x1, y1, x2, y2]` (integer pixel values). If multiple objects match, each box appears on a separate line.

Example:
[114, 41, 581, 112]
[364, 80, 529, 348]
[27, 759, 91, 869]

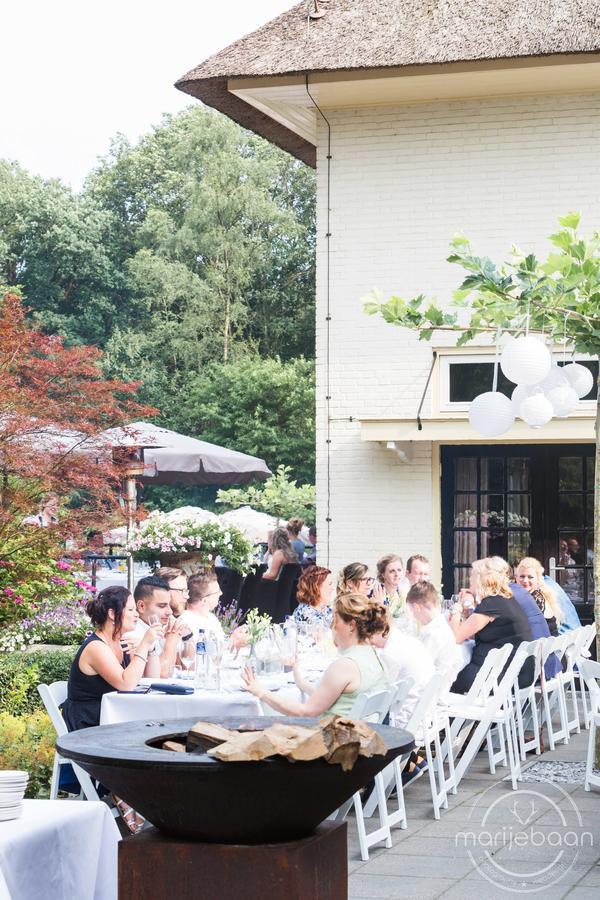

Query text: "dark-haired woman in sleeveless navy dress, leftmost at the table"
[62, 585, 161, 731]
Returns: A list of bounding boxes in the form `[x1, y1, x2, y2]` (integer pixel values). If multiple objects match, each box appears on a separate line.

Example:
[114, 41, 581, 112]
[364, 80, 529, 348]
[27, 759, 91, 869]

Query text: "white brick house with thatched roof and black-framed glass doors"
[179, 0, 600, 616]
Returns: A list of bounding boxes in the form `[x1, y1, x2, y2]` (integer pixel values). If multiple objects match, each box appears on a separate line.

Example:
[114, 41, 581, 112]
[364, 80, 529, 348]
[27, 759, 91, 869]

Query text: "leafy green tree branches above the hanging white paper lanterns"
[364, 213, 600, 356]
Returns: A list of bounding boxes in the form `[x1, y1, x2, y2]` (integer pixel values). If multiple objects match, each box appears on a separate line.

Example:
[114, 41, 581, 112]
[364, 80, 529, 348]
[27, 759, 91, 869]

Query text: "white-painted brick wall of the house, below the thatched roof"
[317, 93, 600, 569]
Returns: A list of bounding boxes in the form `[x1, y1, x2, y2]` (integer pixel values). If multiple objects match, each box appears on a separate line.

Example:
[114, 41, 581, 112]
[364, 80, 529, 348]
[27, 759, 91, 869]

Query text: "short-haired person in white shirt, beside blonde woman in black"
[406, 581, 462, 687]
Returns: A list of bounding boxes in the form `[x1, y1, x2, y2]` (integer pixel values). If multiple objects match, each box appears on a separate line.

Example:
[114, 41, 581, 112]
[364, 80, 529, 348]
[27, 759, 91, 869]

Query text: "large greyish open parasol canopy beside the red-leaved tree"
[100, 422, 272, 484]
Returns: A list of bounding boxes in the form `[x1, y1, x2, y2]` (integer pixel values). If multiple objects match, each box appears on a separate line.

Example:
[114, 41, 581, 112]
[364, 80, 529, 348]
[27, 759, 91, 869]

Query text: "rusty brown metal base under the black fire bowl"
[119, 822, 348, 900]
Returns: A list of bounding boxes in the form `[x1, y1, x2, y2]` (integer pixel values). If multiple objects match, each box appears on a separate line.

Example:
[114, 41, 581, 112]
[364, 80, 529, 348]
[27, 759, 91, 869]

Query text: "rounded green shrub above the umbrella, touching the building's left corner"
[178, 356, 315, 483]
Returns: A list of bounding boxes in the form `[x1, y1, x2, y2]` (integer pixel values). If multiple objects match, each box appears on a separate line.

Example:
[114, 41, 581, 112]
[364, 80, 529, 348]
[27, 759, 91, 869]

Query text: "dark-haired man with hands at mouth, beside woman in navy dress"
[133, 575, 185, 678]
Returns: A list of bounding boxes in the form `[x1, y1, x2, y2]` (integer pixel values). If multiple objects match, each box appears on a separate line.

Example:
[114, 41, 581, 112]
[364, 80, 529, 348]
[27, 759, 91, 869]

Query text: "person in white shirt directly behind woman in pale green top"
[371, 608, 435, 728]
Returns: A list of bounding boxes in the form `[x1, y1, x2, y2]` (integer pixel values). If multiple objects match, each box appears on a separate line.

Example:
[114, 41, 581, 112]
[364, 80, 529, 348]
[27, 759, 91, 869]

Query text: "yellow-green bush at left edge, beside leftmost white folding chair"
[0, 710, 56, 798]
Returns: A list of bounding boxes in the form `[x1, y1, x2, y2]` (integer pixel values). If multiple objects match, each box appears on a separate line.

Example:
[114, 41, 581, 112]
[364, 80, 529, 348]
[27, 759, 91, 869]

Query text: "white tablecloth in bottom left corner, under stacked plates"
[0, 800, 119, 900]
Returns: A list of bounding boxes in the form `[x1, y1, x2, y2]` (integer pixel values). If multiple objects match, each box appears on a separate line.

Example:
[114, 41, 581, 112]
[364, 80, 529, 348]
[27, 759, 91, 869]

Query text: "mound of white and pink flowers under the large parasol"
[127, 512, 254, 575]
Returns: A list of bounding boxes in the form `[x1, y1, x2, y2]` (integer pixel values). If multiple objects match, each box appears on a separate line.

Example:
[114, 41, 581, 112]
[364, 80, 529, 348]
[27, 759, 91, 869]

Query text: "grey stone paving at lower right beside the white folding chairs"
[348, 712, 600, 900]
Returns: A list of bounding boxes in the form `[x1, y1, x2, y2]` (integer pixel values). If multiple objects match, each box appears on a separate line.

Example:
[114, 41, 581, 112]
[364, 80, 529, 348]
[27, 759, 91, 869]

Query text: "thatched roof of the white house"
[177, 0, 600, 164]
